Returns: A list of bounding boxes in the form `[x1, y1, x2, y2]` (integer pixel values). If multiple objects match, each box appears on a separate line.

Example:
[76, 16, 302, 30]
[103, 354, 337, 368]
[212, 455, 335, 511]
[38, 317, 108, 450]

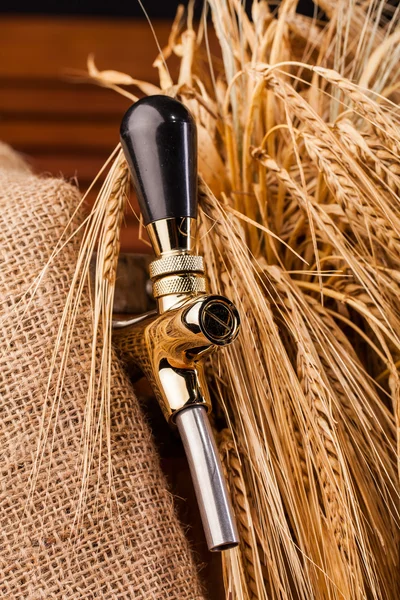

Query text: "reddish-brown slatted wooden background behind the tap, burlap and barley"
[0, 16, 225, 600]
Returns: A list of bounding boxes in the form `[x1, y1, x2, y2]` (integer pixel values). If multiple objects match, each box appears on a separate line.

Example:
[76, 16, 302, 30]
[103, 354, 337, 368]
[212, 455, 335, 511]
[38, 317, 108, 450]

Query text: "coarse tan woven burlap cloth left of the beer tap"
[0, 146, 204, 600]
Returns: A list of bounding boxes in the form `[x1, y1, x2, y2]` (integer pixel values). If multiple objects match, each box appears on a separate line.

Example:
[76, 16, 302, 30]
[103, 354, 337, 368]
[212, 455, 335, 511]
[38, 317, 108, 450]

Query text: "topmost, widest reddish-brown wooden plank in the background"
[0, 15, 175, 82]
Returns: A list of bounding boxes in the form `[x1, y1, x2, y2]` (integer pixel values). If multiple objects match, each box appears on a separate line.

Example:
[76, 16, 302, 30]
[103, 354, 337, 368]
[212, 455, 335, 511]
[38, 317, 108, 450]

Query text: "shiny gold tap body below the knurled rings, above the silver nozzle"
[114, 296, 239, 420]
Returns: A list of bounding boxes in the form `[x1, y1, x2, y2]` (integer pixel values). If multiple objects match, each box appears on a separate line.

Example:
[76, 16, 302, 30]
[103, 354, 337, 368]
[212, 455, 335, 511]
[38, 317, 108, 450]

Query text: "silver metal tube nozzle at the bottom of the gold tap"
[175, 406, 239, 552]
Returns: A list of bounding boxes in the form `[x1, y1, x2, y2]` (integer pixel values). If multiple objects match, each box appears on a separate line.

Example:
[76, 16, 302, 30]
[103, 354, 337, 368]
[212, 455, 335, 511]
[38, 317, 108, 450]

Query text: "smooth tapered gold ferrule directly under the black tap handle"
[146, 217, 197, 257]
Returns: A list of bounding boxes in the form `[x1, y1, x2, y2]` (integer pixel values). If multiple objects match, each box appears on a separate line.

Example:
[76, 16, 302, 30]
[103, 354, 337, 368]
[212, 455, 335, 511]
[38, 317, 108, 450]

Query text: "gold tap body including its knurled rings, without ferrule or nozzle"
[114, 219, 239, 421]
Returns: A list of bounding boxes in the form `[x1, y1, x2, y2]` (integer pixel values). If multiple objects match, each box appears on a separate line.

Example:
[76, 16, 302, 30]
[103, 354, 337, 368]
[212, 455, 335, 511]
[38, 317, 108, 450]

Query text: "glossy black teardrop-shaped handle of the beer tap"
[121, 96, 197, 225]
